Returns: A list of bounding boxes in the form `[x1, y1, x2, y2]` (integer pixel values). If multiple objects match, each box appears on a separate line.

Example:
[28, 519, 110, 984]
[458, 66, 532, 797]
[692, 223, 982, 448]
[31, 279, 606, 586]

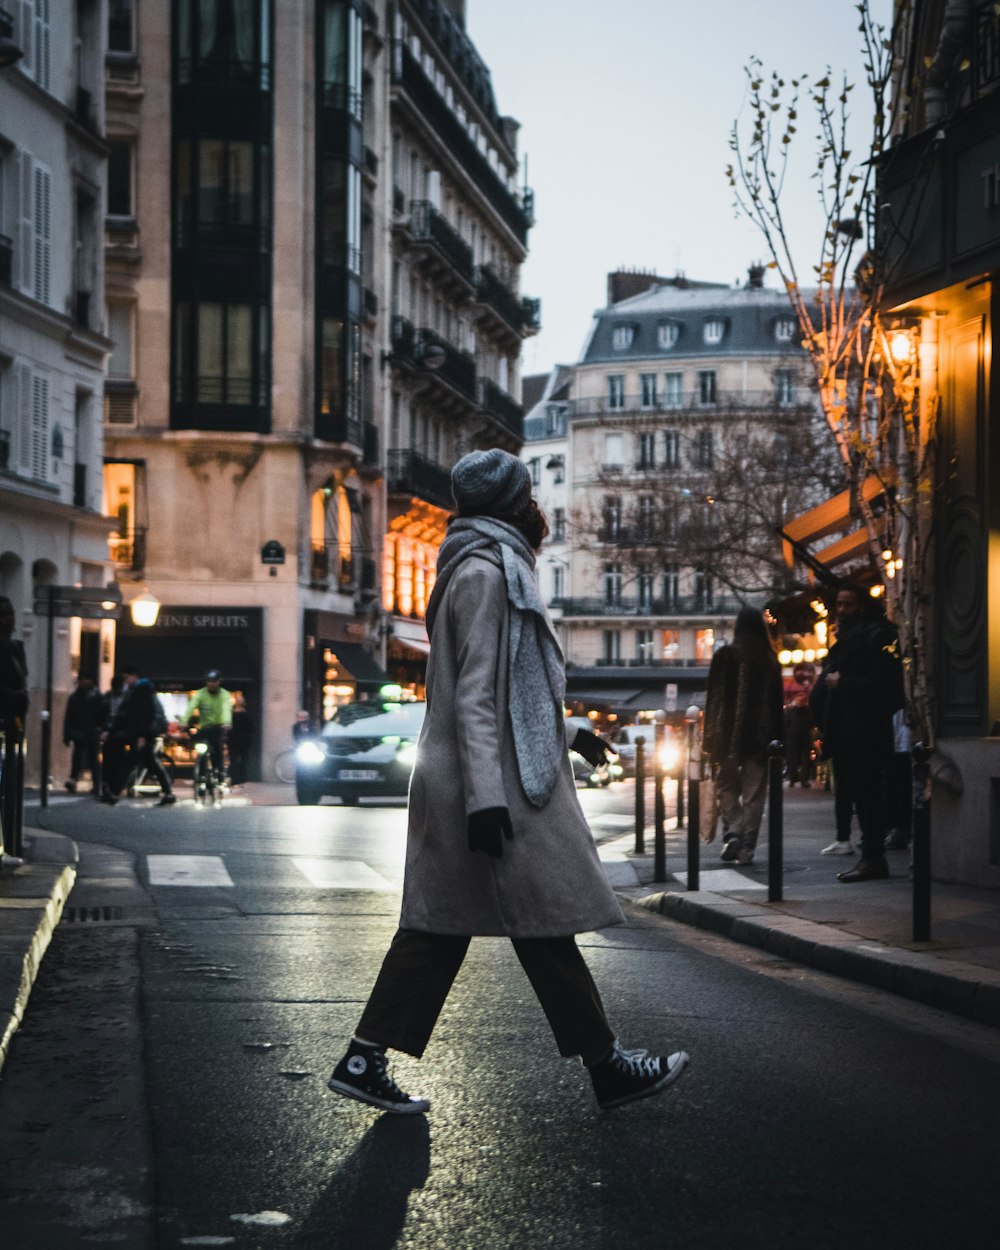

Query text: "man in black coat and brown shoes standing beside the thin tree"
[809, 583, 903, 883]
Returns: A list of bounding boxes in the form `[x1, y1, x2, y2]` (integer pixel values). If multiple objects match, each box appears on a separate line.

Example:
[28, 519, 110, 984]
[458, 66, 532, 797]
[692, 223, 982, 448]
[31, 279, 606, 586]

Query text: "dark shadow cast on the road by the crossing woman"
[301, 1115, 430, 1250]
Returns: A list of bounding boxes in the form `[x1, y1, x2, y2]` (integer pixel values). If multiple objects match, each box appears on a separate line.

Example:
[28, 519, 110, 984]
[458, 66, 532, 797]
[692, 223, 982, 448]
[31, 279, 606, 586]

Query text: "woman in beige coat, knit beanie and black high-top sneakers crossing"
[329, 449, 688, 1113]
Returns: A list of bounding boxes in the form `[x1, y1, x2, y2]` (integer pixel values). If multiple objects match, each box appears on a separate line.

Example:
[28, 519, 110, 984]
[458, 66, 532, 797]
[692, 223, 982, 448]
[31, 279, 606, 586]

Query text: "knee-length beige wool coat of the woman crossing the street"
[400, 551, 625, 938]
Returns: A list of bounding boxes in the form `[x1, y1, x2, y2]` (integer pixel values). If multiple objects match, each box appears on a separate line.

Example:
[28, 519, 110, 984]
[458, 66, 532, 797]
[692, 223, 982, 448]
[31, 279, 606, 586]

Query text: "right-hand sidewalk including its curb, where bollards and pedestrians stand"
[601, 789, 1000, 1026]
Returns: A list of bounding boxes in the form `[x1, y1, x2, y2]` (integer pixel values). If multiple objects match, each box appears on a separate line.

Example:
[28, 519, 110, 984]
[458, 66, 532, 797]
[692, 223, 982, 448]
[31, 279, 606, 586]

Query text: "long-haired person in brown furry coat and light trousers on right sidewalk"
[703, 608, 783, 866]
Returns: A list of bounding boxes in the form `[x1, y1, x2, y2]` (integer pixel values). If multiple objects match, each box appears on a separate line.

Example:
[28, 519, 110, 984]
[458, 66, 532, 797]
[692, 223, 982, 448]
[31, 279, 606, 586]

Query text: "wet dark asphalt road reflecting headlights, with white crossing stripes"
[0, 786, 1000, 1250]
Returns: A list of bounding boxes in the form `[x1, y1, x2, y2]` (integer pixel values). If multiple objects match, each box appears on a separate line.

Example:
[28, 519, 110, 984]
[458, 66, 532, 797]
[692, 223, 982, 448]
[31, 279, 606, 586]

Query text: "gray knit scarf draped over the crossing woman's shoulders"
[426, 516, 566, 808]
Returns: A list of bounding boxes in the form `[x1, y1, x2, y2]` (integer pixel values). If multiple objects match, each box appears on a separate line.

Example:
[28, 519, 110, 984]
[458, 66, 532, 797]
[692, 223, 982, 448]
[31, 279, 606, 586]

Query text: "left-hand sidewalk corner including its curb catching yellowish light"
[0, 830, 79, 1071]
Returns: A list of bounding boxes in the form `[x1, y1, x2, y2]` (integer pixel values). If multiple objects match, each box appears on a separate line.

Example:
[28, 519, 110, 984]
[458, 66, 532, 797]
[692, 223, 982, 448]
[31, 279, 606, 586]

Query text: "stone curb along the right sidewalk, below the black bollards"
[624, 891, 1000, 1028]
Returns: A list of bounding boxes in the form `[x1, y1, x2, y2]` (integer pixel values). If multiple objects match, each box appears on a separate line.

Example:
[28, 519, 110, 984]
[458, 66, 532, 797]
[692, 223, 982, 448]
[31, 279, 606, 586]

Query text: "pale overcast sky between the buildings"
[466, 0, 891, 374]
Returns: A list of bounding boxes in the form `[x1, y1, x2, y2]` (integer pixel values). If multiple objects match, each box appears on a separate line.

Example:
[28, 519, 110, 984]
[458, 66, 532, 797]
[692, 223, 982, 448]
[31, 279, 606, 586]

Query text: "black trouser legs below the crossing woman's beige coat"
[358, 929, 615, 1065]
